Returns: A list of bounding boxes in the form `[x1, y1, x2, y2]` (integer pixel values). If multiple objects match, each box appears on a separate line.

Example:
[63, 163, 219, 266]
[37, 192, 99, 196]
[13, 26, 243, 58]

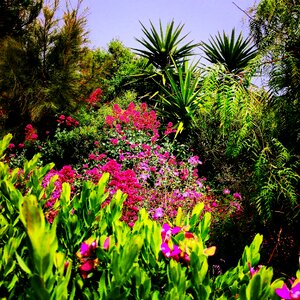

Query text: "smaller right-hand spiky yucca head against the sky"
[201, 29, 257, 74]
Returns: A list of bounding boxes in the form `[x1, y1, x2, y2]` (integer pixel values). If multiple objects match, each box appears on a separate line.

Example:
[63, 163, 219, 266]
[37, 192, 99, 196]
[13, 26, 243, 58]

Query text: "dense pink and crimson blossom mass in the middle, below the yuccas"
[85, 103, 217, 221]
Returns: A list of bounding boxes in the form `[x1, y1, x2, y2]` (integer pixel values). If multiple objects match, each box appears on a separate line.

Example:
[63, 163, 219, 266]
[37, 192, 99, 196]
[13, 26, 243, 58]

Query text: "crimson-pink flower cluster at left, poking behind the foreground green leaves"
[42, 166, 78, 223]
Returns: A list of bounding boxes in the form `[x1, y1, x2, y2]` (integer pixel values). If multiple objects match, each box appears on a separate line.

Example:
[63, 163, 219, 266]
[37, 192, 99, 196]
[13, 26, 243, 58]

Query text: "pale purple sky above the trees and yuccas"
[75, 0, 258, 52]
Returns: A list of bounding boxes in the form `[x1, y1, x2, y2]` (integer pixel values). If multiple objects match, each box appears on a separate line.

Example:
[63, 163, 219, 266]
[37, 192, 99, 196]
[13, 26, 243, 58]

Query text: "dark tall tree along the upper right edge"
[250, 0, 300, 154]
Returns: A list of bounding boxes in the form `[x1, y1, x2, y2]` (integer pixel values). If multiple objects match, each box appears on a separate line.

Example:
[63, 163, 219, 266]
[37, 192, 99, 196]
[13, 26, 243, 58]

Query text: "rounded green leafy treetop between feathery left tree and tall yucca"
[80, 40, 146, 102]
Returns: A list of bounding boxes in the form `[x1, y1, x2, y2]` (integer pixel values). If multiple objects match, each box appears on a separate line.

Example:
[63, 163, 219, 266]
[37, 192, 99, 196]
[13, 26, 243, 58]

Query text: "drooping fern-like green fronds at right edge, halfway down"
[254, 139, 300, 222]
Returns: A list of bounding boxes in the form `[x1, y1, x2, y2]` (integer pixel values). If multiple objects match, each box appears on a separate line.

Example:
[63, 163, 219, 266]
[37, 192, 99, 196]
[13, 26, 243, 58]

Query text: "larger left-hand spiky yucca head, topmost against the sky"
[133, 21, 198, 70]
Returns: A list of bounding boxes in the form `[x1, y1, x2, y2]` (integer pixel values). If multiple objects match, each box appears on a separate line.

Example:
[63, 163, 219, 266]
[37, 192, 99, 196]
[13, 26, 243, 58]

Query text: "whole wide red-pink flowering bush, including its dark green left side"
[9, 98, 242, 226]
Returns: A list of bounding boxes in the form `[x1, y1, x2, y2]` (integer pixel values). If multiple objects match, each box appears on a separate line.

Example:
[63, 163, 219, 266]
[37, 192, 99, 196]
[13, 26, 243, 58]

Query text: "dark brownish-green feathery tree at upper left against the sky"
[0, 0, 86, 132]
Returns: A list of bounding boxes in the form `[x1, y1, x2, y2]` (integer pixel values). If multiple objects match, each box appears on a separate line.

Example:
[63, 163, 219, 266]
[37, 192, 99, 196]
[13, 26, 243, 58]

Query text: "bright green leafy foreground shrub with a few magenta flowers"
[0, 136, 300, 300]
